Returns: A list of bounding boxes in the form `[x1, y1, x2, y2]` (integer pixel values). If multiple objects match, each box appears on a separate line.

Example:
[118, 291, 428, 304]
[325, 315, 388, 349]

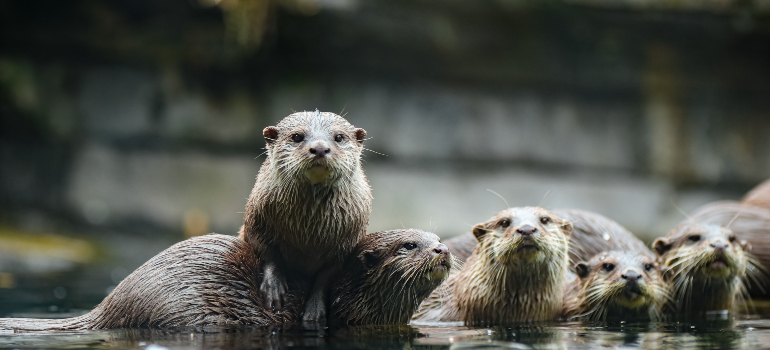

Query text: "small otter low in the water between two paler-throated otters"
[562, 248, 668, 321]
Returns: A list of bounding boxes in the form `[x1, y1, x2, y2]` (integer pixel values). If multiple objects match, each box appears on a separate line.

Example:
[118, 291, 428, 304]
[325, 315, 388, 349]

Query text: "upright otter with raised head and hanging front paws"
[240, 111, 372, 323]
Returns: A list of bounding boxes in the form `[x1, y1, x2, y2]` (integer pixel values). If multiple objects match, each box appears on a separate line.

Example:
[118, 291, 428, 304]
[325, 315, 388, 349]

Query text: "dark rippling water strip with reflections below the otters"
[0, 319, 770, 349]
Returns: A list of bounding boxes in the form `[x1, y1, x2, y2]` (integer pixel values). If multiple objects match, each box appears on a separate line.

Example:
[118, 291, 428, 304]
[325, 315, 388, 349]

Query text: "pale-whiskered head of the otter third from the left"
[473, 207, 572, 265]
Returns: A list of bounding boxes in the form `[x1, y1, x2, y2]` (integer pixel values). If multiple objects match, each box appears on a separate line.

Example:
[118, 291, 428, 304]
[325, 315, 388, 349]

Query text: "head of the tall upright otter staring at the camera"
[262, 110, 366, 184]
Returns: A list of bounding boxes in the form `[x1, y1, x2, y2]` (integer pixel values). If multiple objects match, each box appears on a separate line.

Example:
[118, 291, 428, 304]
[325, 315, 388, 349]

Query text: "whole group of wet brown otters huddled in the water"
[0, 111, 770, 331]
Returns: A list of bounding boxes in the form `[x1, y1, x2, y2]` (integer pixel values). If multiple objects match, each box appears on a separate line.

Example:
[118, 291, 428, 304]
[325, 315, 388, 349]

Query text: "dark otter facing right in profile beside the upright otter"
[329, 229, 452, 325]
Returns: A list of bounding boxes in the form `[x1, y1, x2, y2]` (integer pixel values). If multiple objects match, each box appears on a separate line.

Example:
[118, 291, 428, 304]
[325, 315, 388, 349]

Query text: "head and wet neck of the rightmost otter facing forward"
[653, 217, 757, 318]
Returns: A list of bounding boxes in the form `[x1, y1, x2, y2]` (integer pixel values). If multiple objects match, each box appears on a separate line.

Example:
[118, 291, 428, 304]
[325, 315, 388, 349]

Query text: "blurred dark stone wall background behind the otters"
[0, 0, 770, 316]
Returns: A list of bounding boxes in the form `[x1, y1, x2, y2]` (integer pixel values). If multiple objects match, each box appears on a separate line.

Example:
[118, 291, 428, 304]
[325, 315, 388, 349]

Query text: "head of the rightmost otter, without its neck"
[653, 223, 751, 279]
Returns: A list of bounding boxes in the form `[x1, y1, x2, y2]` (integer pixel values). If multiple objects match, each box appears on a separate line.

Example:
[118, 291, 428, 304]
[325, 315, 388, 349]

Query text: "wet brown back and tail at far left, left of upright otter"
[0, 234, 302, 331]
